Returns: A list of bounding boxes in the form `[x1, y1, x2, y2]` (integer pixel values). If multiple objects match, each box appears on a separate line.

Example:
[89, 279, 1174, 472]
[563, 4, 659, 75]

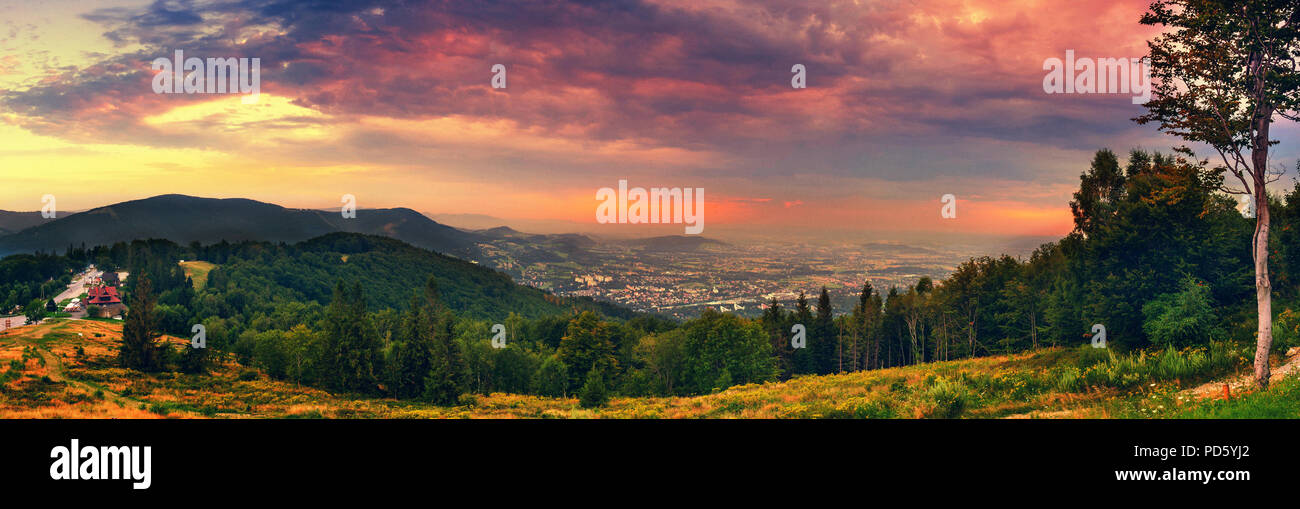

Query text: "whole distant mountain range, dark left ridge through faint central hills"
[0, 195, 727, 262]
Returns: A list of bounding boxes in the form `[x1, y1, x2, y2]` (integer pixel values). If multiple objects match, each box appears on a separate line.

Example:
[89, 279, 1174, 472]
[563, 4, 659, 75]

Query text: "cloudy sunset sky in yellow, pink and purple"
[0, 0, 1297, 240]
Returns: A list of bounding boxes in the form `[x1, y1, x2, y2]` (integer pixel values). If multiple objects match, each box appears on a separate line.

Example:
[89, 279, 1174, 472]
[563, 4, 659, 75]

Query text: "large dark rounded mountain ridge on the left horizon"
[0, 195, 481, 258]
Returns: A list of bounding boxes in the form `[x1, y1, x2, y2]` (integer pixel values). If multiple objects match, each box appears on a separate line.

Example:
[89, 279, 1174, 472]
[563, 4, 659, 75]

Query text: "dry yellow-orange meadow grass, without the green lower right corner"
[0, 319, 1258, 418]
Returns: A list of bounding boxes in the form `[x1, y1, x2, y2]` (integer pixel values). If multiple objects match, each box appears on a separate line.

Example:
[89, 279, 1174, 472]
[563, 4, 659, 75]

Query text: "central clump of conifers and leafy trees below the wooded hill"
[229, 279, 779, 404]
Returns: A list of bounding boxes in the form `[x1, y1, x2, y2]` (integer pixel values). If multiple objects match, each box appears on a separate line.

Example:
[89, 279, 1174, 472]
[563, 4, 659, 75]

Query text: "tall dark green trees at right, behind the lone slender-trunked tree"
[811, 149, 1300, 373]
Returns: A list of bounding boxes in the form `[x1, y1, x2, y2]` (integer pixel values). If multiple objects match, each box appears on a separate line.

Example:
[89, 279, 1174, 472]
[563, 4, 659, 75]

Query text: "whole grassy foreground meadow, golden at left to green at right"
[0, 319, 1300, 418]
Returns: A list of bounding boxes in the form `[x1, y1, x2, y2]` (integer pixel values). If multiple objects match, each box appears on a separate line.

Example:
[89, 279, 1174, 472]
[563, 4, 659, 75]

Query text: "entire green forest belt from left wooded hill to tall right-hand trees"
[7, 149, 1300, 405]
